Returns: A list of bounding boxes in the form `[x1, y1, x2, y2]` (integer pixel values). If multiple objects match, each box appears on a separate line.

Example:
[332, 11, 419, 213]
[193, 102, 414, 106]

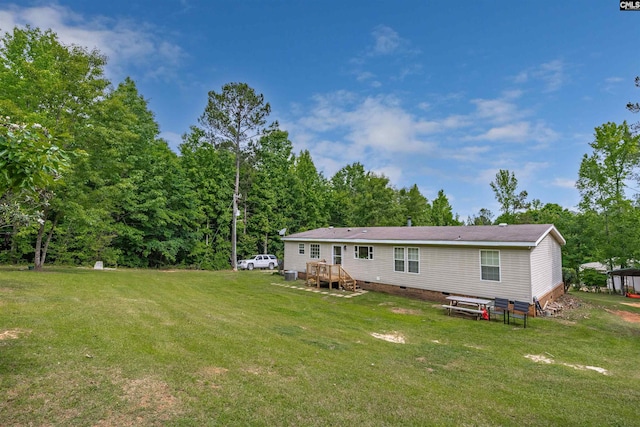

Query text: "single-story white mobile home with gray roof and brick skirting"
[282, 224, 566, 306]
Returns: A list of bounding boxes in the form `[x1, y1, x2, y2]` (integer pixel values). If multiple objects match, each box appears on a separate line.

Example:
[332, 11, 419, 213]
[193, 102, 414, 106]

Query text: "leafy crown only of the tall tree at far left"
[0, 26, 109, 138]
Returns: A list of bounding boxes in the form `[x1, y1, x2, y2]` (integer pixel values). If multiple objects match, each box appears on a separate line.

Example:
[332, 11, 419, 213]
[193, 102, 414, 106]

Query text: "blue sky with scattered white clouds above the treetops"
[0, 0, 640, 219]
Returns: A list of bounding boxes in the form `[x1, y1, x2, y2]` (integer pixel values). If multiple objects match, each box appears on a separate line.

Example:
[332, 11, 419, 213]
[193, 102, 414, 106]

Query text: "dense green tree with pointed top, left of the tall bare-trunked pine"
[65, 79, 197, 267]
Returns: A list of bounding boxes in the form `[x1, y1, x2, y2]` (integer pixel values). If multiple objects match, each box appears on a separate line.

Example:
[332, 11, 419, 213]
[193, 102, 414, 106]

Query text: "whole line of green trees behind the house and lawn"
[0, 26, 640, 284]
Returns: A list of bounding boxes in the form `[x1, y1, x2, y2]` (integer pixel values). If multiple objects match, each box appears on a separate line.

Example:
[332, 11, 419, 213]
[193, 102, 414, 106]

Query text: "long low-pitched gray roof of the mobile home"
[283, 224, 566, 247]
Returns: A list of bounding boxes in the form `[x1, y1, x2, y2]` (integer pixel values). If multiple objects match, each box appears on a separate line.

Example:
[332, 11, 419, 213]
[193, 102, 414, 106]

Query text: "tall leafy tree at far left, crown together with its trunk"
[0, 27, 108, 269]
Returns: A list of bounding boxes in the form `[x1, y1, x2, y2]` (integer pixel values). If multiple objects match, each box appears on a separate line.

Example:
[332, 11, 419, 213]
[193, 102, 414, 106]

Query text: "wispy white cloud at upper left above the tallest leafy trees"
[0, 4, 186, 79]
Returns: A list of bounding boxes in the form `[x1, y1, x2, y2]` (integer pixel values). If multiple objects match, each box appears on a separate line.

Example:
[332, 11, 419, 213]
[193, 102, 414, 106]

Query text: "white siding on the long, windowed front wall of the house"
[284, 242, 531, 301]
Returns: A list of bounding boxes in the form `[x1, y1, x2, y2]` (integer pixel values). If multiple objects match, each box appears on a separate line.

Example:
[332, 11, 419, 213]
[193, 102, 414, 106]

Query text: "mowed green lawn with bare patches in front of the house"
[0, 268, 640, 426]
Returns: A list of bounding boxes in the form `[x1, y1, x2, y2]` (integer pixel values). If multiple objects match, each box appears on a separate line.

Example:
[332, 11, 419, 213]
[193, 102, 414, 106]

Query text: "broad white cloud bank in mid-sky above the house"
[286, 85, 557, 196]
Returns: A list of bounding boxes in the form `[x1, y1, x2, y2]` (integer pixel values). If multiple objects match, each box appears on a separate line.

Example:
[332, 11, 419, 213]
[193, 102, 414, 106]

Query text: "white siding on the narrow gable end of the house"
[531, 234, 562, 298]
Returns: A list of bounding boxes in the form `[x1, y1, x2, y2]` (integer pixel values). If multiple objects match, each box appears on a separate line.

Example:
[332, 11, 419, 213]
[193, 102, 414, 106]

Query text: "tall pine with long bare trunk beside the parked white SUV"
[199, 83, 271, 271]
